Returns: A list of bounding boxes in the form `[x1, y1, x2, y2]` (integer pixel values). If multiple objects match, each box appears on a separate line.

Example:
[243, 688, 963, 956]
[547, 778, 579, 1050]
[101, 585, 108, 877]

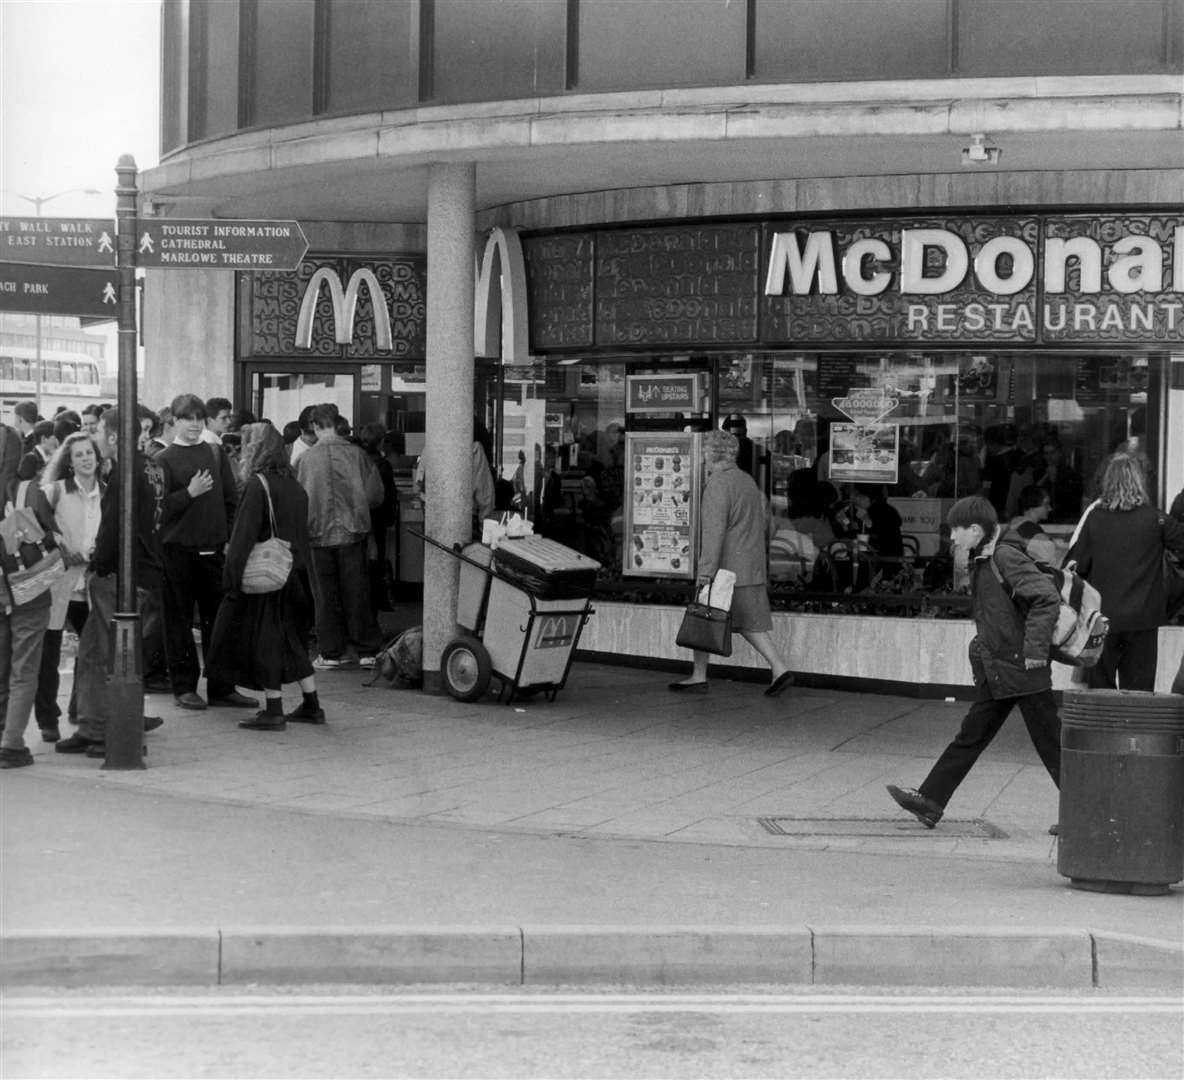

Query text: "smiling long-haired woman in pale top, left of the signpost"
[33, 431, 105, 743]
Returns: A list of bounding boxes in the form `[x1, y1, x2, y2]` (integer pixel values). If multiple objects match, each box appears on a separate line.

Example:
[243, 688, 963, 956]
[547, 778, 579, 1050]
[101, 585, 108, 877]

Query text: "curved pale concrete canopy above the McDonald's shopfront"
[142, 75, 1184, 224]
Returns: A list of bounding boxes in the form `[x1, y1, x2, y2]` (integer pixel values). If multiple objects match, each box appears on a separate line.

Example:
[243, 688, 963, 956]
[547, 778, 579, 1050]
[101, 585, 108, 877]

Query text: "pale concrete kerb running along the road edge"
[0, 926, 1184, 995]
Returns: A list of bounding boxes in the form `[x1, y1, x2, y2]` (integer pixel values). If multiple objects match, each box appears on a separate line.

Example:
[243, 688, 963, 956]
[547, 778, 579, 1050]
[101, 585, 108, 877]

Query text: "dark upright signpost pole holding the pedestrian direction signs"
[103, 154, 146, 770]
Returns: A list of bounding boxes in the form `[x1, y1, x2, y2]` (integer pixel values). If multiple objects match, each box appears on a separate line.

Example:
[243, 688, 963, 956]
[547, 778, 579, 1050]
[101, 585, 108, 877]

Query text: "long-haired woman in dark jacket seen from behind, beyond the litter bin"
[1066, 454, 1184, 690]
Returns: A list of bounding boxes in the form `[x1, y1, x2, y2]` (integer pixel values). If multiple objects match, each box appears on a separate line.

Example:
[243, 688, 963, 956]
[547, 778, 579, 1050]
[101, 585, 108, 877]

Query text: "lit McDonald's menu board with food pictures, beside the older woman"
[622, 431, 700, 581]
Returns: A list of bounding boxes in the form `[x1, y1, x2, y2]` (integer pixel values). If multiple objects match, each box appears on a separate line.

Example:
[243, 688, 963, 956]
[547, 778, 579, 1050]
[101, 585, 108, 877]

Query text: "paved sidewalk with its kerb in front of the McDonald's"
[0, 663, 1184, 985]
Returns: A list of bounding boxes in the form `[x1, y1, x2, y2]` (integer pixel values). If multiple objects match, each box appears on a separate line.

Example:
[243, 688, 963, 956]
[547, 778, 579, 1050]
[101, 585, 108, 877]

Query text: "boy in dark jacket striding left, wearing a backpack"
[888, 495, 1061, 829]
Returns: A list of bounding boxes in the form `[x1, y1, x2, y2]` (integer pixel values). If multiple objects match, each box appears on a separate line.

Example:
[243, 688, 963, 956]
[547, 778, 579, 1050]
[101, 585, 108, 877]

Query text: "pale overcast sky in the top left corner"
[0, 0, 160, 218]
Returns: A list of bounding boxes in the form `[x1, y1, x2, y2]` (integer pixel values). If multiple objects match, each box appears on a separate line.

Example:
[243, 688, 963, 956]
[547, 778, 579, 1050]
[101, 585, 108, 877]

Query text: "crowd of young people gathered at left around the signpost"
[0, 393, 398, 769]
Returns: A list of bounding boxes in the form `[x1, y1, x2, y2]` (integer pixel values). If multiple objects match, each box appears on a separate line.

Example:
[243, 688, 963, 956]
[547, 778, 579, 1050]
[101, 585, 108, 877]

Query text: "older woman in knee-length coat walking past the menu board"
[670, 431, 793, 698]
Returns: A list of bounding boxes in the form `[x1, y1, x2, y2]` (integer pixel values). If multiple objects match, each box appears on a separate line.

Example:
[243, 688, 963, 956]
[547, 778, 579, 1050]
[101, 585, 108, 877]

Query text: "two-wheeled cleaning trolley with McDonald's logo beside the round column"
[423, 535, 600, 702]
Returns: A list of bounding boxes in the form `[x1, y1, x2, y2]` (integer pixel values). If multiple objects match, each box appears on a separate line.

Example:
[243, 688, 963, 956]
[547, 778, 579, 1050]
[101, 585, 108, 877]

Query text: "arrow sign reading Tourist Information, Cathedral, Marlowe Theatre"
[135, 218, 308, 270]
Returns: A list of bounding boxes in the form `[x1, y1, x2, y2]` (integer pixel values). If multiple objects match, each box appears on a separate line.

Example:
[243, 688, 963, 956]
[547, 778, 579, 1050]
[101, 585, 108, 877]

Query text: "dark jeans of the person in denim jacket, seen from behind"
[311, 539, 382, 660]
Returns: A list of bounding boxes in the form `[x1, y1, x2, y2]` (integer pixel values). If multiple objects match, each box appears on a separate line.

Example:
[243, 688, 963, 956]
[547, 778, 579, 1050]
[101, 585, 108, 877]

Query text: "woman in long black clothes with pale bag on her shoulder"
[206, 423, 324, 731]
